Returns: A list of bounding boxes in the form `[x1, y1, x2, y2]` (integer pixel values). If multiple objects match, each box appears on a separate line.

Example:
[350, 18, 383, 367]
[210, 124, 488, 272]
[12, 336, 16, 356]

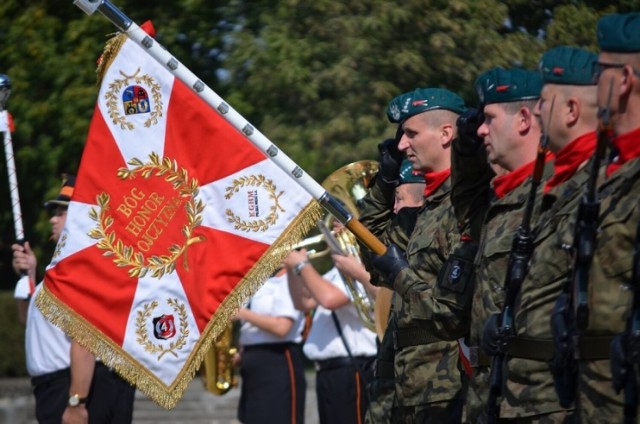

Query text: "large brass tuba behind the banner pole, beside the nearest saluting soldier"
[319, 160, 378, 332]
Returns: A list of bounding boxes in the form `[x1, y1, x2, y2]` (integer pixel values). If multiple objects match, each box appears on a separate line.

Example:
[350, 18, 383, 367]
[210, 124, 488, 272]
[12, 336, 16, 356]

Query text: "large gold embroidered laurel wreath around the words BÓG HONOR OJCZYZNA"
[89, 153, 204, 278]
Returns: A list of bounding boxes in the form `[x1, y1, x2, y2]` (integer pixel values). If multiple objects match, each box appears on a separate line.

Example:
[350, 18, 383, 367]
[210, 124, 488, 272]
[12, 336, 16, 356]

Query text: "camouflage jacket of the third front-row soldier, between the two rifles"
[501, 164, 590, 418]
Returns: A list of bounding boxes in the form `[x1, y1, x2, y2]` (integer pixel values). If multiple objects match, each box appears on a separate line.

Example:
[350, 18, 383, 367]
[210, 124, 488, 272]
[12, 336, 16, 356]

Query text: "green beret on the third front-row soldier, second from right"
[538, 46, 598, 85]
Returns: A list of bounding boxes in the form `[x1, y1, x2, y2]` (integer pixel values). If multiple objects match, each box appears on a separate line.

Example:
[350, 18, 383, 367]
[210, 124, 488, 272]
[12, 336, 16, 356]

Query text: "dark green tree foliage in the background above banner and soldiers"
[0, 0, 638, 288]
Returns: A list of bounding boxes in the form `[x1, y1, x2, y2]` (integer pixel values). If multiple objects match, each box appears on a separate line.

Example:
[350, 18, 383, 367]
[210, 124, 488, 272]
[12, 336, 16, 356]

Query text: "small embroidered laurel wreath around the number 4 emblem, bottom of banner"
[136, 299, 189, 361]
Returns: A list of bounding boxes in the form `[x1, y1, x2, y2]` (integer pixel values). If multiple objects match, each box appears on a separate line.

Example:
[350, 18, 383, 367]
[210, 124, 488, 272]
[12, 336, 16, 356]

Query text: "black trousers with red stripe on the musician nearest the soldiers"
[316, 358, 373, 424]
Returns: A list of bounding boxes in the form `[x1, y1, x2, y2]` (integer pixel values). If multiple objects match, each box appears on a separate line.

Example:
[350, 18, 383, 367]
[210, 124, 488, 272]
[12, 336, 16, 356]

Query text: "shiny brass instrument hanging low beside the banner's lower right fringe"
[200, 323, 238, 395]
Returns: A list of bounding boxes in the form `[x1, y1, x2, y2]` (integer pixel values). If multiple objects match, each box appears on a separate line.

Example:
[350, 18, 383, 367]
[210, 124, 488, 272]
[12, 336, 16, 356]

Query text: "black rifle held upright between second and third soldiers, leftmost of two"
[486, 97, 555, 424]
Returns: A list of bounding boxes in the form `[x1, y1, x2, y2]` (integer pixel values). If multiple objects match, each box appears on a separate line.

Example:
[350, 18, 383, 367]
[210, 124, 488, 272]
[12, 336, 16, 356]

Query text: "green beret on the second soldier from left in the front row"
[475, 68, 542, 105]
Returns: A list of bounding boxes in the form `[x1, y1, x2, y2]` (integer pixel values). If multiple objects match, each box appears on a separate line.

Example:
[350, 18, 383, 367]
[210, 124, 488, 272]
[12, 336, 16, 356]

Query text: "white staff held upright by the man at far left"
[0, 74, 31, 299]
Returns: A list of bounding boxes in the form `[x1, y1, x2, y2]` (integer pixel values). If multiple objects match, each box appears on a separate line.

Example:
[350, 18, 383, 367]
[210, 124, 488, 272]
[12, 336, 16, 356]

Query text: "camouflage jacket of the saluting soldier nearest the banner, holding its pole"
[360, 174, 470, 407]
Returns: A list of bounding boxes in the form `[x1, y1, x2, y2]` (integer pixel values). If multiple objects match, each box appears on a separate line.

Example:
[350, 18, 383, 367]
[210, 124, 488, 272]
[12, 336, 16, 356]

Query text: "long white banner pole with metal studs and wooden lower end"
[74, 0, 386, 254]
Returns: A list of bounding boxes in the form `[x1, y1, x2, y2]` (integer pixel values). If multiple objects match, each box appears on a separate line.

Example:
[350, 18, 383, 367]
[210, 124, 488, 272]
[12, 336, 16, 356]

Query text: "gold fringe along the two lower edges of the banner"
[36, 200, 325, 409]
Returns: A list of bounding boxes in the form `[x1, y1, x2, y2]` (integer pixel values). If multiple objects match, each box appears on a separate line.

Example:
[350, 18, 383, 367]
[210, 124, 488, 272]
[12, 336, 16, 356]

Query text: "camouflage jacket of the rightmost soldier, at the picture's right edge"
[578, 154, 640, 422]
